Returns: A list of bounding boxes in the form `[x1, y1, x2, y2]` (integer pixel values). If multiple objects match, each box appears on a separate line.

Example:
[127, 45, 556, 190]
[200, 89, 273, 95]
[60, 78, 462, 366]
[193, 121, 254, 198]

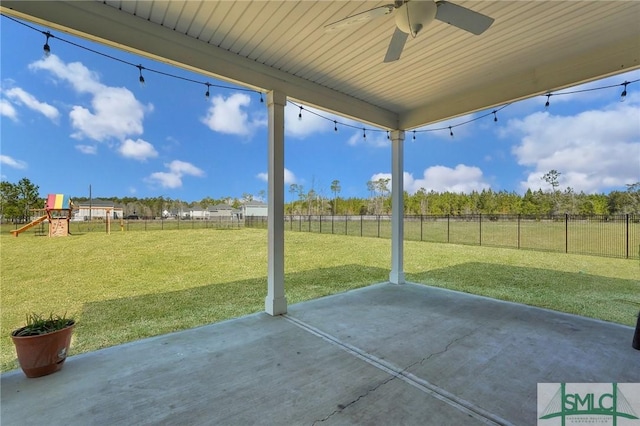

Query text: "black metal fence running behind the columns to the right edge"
[245, 214, 640, 259]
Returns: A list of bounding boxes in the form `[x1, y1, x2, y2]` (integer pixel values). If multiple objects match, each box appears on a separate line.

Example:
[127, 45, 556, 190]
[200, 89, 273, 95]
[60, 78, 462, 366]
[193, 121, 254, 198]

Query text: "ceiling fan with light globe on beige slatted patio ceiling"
[324, 0, 493, 62]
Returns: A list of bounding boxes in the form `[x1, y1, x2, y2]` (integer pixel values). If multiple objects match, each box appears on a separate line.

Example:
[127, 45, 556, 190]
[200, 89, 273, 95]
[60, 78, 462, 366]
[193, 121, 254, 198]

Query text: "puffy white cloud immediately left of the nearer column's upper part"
[202, 93, 267, 136]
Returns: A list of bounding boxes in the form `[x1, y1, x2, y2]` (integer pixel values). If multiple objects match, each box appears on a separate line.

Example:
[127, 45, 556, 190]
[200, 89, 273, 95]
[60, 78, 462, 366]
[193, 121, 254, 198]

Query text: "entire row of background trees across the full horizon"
[0, 170, 640, 222]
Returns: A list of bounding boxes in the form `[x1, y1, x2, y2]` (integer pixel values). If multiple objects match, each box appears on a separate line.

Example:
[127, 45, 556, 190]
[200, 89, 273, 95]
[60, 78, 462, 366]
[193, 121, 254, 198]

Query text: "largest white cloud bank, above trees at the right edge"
[505, 99, 640, 193]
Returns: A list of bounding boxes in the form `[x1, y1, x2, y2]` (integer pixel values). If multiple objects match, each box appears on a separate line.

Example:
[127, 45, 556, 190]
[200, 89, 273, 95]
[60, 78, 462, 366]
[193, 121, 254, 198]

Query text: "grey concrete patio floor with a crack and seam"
[0, 283, 640, 426]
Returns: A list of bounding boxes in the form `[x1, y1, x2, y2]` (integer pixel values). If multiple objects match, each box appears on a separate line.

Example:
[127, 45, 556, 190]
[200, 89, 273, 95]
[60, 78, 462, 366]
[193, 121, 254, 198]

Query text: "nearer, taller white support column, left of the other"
[264, 91, 287, 315]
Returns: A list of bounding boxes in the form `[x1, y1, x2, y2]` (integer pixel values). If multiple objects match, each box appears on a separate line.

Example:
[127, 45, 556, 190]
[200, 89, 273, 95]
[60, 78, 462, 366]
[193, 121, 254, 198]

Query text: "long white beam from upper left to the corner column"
[0, 0, 398, 129]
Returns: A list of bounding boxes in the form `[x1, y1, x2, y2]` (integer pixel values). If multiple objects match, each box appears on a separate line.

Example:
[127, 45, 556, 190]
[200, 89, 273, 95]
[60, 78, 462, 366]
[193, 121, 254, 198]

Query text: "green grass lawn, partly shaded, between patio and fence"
[0, 229, 640, 371]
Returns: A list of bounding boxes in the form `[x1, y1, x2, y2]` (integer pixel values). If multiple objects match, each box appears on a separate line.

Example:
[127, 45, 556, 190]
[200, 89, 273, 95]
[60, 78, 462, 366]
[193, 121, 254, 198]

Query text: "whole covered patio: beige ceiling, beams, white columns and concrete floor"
[0, 0, 640, 424]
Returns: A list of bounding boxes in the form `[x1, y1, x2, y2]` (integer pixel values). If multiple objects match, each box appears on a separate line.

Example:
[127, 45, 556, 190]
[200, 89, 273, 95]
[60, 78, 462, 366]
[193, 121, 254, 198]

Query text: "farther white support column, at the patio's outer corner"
[389, 130, 405, 284]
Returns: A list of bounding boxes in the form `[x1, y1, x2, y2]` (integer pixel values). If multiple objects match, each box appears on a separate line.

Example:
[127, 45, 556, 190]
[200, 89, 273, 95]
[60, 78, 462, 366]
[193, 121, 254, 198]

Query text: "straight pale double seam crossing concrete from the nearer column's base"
[282, 314, 512, 426]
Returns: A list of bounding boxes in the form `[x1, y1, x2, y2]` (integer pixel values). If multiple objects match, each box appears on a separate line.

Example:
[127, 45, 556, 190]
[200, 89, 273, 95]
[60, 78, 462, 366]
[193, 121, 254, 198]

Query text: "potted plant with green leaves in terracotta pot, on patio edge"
[11, 314, 76, 377]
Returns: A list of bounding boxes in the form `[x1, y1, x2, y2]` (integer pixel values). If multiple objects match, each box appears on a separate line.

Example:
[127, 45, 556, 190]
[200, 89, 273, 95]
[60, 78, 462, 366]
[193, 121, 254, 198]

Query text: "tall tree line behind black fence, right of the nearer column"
[292, 170, 640, 216]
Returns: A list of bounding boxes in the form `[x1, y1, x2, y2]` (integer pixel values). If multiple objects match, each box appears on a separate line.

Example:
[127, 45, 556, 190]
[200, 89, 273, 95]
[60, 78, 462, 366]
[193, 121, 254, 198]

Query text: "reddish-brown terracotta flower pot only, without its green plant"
[11, 323, 75, 377]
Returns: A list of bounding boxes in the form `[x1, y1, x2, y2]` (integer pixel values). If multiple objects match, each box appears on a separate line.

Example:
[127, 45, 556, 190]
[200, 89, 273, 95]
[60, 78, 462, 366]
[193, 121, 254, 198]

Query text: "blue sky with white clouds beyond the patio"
[0, 17, 640, 201]
